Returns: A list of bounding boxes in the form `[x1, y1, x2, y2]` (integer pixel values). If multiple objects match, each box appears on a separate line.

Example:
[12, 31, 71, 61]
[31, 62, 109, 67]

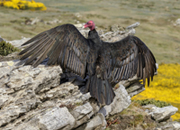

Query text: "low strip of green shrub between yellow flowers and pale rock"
[133, 99, 171, 108]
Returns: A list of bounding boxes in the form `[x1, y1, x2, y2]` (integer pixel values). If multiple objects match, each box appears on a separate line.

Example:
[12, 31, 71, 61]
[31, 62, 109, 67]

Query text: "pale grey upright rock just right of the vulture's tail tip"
[99, 85, 131, 116]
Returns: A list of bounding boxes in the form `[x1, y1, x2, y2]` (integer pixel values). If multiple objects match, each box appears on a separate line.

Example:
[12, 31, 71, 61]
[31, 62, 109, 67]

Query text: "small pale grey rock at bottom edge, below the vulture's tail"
[84, 113, 107, 130]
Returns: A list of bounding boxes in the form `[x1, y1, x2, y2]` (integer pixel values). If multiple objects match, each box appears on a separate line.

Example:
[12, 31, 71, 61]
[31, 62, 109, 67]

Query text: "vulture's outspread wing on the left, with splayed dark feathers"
[19, 24, 91, 77]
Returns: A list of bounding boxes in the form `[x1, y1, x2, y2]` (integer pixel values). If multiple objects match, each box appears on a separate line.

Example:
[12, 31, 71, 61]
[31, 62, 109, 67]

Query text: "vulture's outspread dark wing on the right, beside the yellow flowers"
[96, 36, 156, 85]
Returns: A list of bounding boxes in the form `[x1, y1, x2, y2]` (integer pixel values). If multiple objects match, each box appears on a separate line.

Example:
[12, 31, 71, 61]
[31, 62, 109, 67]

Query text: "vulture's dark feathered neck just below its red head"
[88, 29, 102, 46]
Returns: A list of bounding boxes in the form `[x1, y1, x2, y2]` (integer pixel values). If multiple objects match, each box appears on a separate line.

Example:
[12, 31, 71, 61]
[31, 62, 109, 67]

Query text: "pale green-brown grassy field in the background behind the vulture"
[0, 0, 180, 63]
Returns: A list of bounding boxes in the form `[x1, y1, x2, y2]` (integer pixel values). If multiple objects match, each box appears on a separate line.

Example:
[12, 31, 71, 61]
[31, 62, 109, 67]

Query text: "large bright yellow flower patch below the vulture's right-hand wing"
[132, 64, 180, 120]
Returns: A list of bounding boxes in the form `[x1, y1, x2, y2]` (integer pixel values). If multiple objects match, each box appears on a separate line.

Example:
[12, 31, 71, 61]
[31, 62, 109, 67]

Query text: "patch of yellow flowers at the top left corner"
[0, 0, 46, 10]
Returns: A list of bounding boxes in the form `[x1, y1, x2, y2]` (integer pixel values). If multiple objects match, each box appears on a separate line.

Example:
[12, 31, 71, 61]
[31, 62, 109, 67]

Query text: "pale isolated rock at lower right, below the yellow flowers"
[149, 106, 178, 122]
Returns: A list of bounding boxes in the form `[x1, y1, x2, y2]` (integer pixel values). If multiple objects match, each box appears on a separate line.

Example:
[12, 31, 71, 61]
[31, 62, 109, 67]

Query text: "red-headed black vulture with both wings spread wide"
[19, 21, 156, 105]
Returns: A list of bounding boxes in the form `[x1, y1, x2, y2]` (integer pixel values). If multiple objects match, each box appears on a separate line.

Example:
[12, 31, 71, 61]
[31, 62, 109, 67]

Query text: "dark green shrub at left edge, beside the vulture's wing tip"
[0, 41, 20, 56]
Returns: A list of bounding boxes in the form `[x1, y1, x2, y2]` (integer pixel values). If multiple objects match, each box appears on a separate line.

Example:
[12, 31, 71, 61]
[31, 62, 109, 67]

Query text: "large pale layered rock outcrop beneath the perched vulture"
[0, 61, 131, 130]
